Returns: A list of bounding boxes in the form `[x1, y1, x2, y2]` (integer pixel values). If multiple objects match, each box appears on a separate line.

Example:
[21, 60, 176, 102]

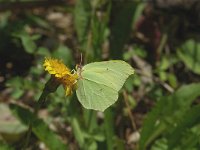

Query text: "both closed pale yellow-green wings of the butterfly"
[76, 60, 134, 111]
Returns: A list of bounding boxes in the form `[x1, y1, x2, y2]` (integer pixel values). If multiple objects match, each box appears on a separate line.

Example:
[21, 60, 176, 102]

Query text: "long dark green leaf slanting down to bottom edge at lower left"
[10, 104, 68, 150]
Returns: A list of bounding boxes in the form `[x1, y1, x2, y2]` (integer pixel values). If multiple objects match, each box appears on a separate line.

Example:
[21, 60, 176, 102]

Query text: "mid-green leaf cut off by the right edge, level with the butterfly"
[177, 39, 200, 74]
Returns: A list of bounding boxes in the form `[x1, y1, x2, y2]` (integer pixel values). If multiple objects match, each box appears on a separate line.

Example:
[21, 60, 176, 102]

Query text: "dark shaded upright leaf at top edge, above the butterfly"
[110, 1, 137, 59]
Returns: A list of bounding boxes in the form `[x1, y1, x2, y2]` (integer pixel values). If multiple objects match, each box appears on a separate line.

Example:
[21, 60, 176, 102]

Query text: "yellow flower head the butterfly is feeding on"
[43, 58, 78, 96]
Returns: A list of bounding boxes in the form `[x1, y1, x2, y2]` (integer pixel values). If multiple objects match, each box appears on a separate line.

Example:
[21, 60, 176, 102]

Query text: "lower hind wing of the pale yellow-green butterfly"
[76, 79, 118, 111]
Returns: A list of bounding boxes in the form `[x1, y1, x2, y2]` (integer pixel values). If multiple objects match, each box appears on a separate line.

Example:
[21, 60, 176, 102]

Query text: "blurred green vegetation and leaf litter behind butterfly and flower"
[0, 0, 200, 150]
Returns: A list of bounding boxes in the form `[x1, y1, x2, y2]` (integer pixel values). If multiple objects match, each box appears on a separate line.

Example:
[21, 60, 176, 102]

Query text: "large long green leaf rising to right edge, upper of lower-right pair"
[139, 84, 200, 150]
